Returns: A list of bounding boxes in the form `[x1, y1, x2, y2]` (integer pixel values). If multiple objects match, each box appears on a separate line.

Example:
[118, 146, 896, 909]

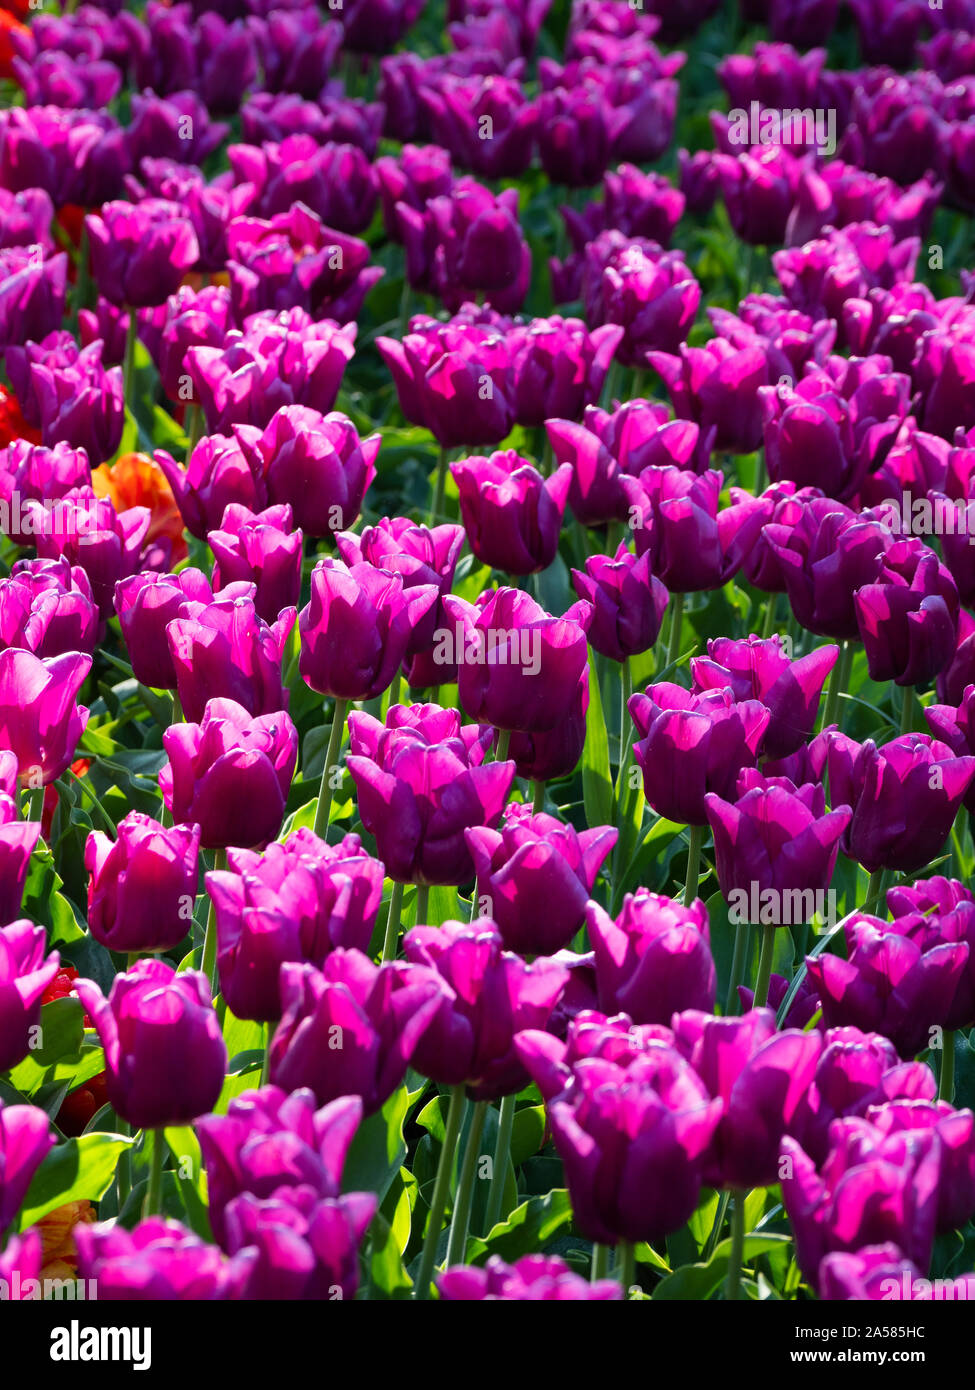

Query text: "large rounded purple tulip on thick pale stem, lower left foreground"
[75, 959, 227, 1129]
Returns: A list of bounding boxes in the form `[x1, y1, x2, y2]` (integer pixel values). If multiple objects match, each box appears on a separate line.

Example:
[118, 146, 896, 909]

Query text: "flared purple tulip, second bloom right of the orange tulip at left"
[228, 406, 381, 537]
